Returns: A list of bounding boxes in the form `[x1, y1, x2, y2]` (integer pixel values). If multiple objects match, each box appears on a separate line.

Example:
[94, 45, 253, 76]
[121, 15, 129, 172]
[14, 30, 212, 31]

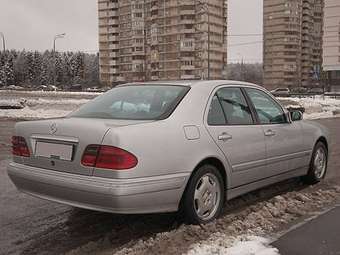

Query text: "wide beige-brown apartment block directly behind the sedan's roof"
[98, 0, 227, 85]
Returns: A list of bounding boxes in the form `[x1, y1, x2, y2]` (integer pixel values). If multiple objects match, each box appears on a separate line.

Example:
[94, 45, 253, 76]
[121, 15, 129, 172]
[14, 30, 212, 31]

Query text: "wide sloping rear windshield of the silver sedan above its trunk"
[69, 85, 189, 120]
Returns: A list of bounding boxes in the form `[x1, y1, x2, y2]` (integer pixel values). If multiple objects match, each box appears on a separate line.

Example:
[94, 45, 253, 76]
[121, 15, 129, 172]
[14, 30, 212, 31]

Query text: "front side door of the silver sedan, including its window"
[245, 88, 308, 176]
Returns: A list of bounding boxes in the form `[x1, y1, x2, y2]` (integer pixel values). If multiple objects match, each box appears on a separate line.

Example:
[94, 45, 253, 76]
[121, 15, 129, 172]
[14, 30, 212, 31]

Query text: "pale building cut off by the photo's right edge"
[323, 0, 340, 91]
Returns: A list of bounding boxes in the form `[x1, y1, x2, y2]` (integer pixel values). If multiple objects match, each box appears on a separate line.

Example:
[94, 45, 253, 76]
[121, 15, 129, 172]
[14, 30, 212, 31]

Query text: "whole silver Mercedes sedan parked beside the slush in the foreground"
[8, 81, 329, 223]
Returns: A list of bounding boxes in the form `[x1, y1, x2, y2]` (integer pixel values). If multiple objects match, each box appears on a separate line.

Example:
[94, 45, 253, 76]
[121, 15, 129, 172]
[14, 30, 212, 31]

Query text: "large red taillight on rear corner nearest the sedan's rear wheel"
[81, 145, 138, 170]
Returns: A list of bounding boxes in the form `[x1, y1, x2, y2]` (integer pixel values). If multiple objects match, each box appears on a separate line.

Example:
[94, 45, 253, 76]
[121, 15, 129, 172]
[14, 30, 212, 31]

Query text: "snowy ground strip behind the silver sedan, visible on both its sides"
[0, 91, 340, 119]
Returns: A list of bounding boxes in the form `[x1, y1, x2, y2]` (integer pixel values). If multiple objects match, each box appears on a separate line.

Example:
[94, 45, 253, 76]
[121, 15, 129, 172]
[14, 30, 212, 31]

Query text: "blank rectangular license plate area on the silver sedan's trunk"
[35, 141, 73, 161]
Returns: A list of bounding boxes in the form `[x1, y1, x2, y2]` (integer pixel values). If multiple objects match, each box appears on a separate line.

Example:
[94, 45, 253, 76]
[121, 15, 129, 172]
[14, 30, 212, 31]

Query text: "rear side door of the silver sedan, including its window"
[206, 87, 266, 188]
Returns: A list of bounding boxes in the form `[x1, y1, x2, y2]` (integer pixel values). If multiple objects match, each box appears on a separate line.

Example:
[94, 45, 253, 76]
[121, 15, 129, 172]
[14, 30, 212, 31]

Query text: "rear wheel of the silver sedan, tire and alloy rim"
[181, 165, 225, 224]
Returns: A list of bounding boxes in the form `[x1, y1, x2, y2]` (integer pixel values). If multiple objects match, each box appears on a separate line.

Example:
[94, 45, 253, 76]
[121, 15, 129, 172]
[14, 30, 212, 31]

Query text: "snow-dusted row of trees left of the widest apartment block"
[0, 50, 99, 87]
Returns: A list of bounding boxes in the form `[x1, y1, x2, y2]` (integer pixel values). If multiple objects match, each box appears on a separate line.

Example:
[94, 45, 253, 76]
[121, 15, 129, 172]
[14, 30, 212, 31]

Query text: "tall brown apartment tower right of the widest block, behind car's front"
[263, 0, 324, 88]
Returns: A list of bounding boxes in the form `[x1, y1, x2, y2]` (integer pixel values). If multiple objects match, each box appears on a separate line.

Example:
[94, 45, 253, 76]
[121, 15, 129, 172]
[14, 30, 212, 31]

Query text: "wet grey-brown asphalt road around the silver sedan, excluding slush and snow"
[0, 118, 340, 254]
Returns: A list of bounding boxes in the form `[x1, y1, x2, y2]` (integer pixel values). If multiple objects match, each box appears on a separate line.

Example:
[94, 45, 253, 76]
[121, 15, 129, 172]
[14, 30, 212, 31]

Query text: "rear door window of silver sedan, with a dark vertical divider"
[208, 88, 253, 126]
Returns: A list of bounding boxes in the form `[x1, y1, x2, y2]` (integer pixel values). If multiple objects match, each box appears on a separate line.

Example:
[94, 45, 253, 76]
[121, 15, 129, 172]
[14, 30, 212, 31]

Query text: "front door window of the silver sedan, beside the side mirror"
[246, 88, 287, 124]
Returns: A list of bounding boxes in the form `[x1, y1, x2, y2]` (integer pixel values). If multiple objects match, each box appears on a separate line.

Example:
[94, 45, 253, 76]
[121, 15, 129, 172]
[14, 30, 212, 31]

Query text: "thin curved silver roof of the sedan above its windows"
[118, 80, 263, 89]
